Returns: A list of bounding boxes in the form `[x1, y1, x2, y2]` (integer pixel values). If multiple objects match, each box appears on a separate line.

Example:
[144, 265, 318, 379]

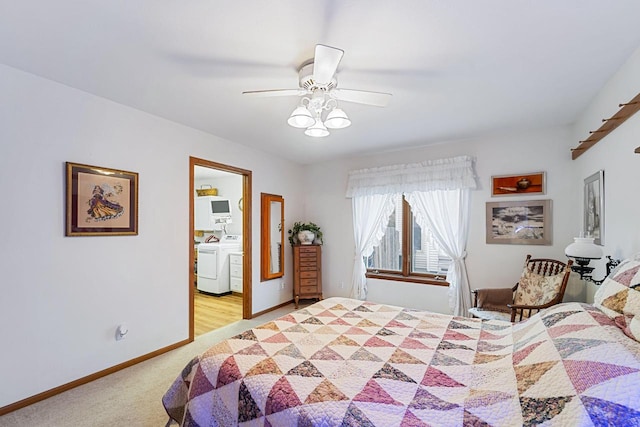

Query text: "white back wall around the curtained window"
[306, 128, 579, 313]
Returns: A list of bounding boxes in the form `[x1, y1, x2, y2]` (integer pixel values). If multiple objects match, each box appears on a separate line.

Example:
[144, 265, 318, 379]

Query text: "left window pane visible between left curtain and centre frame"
[365, 196, 402, 271]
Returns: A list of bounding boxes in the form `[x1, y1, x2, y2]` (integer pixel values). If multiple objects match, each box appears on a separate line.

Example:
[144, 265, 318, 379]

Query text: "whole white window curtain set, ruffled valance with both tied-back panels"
[347, 156, 476, 315]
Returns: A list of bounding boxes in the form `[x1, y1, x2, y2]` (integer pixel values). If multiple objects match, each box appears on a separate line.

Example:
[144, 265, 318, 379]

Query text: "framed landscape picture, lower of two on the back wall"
[486, 199, 551, 245]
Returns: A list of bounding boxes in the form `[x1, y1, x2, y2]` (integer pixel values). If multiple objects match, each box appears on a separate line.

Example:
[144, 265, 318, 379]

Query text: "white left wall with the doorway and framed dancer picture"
[0, 65, 302, 407]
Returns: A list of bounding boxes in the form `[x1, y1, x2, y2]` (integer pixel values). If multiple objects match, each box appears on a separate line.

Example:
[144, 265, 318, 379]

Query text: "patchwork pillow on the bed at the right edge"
[593, 254, 640, 341]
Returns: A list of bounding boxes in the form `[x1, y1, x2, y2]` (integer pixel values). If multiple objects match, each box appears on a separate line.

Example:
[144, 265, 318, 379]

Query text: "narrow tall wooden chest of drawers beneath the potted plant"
[293, 245, 322, 308]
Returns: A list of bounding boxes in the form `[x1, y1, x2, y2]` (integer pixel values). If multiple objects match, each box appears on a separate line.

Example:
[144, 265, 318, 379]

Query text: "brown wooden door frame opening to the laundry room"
[187, 156, 253, 341]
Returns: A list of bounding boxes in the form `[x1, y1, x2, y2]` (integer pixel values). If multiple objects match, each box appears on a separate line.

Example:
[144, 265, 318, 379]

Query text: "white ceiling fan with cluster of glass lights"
[242, 44, 391, 137]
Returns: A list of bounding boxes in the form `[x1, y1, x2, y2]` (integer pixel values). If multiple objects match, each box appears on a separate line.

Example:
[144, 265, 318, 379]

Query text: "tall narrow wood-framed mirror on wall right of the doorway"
[260, 193, 284, 281]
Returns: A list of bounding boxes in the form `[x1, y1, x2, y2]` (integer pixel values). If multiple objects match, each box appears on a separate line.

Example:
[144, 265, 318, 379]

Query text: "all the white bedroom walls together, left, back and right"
[0, 42, 640, 407]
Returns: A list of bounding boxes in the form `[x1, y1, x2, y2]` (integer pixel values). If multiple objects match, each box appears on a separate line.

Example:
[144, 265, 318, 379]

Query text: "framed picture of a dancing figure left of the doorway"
[65, 162, 138, 236]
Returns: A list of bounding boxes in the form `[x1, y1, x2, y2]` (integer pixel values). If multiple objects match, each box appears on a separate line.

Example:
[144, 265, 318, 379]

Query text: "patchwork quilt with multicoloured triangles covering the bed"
[163, 298, 640, 427]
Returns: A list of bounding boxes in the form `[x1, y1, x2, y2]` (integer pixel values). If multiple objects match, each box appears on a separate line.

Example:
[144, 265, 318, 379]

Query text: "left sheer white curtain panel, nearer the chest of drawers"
[351, 194, 394, 299]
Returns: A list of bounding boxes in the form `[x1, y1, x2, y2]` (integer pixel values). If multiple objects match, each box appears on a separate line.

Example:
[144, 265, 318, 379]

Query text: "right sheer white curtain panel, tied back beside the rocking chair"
[406, 188, 471, 316]
